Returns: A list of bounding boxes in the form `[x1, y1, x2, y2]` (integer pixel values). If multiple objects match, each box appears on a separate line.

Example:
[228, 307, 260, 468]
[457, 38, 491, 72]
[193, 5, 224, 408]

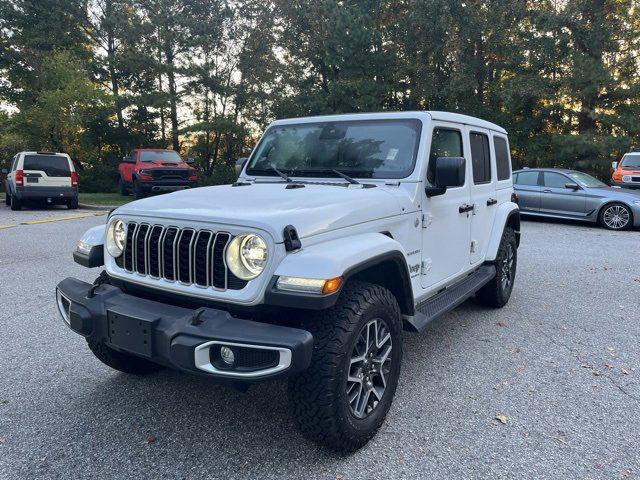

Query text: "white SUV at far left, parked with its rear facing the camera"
[3, 152, 78, 210]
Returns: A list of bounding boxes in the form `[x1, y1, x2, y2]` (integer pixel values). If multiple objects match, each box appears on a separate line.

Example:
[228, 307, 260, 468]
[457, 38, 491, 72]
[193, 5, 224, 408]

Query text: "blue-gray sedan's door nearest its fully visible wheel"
[540, 172, 586, 217]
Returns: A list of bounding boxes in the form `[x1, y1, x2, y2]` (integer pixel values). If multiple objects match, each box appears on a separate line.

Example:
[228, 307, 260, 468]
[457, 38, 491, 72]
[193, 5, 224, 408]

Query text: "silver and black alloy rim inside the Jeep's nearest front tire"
[347, 318, 393, 419]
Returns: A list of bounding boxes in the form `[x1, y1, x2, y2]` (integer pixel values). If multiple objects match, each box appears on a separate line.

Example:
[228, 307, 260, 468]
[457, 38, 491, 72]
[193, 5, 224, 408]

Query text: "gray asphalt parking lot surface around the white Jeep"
[0, 206, 640, 479]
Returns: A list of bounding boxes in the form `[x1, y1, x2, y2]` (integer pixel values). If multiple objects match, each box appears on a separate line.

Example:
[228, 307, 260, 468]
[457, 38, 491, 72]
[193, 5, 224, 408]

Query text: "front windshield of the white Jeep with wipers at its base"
[247, 120, 421, 178]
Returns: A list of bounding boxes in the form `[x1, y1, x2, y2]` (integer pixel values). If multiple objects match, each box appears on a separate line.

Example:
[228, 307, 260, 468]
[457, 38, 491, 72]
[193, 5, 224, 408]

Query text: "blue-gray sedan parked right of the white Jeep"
[513, 168, 640, 230]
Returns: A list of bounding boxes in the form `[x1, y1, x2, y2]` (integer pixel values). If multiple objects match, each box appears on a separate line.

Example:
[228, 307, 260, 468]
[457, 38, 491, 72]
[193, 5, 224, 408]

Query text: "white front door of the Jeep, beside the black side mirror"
[421, 122, 472, 288]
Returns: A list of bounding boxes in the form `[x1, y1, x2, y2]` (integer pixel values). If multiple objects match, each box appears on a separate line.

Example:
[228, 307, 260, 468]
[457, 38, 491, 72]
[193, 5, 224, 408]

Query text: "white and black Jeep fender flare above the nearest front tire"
[265, 232, 414, 315]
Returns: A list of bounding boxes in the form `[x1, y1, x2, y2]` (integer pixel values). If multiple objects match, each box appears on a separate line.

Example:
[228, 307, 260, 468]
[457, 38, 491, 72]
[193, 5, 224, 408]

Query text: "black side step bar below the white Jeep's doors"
[405, 265, 496, 332]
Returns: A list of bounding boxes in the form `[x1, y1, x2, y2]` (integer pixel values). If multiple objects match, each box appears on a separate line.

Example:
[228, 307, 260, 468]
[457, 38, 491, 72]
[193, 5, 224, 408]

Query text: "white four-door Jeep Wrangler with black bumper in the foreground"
[57, 112, 520, 451]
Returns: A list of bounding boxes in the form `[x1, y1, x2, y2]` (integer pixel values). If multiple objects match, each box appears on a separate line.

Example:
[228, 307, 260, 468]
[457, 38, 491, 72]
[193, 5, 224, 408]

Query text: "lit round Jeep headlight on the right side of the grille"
[226, 233, 268, 280]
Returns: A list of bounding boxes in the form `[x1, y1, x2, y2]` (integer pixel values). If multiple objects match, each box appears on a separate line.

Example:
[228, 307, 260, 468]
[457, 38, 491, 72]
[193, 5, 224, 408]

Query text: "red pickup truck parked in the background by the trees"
[118, 148, 198, 199]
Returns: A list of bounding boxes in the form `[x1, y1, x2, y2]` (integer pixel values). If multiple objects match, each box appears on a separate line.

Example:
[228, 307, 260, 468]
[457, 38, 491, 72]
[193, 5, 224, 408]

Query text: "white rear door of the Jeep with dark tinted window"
[467, 127, 498, 264]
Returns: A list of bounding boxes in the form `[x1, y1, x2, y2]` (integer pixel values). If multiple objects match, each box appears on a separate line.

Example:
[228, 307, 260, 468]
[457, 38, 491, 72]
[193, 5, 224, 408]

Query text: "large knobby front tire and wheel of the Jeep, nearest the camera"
[288, 282, 402, 452]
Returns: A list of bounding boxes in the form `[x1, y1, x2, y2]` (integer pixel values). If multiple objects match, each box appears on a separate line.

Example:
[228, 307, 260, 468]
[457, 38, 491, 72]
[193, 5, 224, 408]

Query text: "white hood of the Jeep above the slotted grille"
[116, 182, 411, 242]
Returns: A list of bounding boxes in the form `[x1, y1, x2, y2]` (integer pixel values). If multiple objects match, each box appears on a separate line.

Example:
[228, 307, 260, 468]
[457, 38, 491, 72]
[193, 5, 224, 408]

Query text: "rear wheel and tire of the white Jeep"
[476, 227, 518, 308]
